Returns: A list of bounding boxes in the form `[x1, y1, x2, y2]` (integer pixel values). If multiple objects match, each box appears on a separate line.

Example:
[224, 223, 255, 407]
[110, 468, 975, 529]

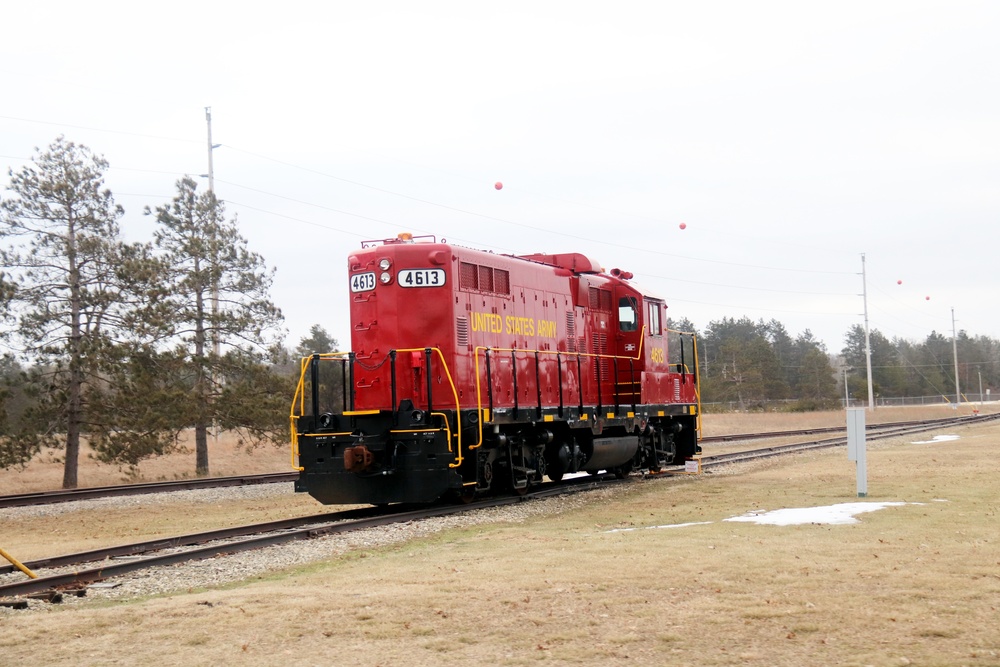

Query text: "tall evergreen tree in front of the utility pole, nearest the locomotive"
[146, 178, 288, 475]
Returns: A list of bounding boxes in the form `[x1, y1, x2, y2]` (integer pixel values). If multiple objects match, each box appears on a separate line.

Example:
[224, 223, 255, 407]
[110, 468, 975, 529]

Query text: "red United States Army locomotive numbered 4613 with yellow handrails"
[291, 234, 700, 505]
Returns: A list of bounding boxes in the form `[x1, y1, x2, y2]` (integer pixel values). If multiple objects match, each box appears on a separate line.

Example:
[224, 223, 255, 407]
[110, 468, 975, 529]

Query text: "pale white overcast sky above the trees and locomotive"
[0, 0, 1000, 352]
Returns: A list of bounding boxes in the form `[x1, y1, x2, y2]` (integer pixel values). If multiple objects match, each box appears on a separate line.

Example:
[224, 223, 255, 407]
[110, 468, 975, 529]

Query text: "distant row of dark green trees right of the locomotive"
[670, 317, 1000, 410]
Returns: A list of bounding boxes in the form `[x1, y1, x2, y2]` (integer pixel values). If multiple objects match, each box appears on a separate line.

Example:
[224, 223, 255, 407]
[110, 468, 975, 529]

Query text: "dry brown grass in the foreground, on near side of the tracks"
[0, 413, 1000, 666]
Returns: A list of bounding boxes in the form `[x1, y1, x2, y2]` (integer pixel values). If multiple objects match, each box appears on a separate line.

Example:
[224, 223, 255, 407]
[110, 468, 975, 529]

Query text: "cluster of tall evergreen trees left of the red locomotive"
[0, 137, 288, 488]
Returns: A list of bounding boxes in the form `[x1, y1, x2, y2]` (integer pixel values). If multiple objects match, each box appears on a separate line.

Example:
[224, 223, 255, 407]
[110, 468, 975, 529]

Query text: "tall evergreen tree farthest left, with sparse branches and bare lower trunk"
[0, 137, 163, 488]
